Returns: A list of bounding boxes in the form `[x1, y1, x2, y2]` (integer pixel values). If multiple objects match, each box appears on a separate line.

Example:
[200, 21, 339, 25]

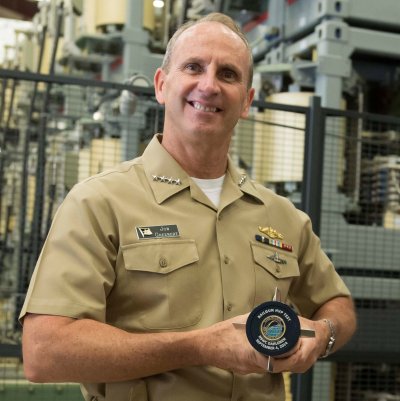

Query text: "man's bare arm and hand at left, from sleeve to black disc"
[23, 315, 267, 383]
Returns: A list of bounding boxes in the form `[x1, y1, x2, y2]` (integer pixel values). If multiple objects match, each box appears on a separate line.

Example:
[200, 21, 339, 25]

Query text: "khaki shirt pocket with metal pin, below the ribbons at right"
[251, 243, 300, 305]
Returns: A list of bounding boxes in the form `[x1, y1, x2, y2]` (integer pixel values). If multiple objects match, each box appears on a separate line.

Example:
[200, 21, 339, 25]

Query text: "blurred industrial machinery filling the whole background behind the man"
[0, 0, 400, 401]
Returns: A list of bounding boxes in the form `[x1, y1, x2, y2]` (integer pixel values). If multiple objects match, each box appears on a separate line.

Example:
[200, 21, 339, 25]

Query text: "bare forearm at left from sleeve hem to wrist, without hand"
[23, 315, 201, 382]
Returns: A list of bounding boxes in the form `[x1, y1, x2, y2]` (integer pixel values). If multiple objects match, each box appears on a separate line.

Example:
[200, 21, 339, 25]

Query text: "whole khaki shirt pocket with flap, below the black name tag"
[121, 240, 202, 330]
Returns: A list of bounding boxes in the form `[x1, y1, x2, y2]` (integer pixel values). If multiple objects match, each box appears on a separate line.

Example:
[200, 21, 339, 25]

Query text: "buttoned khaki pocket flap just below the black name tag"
[121, 240, 199, 274]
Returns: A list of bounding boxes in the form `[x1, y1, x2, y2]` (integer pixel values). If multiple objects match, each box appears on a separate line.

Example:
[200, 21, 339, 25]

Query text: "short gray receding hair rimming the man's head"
[161, 13, 253, 89]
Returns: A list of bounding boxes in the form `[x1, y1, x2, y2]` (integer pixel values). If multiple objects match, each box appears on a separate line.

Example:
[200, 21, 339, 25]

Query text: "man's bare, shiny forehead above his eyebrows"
[173, 21, 247, 59]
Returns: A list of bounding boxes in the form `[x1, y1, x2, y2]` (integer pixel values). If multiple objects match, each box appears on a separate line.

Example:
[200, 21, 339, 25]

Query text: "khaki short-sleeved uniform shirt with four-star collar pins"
[20, 137, 349, 401]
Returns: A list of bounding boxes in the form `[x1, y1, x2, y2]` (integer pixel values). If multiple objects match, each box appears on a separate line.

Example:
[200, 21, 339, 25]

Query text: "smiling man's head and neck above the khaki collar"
[154, 17, 254, 178]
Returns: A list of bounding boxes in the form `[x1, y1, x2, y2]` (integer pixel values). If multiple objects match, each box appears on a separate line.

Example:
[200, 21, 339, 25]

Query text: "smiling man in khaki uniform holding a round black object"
[21, 14, 355, 401]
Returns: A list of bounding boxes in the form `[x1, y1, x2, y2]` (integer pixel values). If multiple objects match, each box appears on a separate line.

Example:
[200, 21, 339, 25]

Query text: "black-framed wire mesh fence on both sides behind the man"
[0, 71, 400, 401]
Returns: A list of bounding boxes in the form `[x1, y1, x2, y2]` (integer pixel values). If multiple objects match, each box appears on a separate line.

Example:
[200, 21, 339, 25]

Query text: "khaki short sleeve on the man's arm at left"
[20, 182, 118, 321]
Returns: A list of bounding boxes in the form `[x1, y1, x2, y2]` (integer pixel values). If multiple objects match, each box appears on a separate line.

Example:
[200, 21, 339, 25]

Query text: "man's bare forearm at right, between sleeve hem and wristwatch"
[312, 297, 357, 351]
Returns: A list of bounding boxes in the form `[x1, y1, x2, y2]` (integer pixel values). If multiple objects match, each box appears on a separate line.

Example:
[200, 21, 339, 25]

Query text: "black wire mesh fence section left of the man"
[0, 70, 163, 400]
